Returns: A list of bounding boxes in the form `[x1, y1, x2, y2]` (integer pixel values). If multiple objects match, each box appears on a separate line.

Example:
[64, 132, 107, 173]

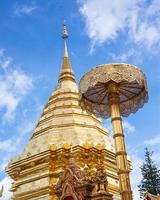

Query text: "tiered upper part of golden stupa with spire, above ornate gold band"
[8, 24, 114, 163]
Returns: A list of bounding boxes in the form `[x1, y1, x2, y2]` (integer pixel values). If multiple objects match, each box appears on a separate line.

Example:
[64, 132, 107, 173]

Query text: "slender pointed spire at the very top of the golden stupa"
[58, 23, 75, 83]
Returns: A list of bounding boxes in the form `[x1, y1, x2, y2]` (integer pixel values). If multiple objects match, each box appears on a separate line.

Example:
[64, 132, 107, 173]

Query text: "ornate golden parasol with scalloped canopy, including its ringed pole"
[79, 63, 148, 200]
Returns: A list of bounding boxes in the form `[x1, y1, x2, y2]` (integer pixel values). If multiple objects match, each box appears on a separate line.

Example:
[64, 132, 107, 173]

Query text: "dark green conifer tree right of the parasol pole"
[138, 148, 160, 198]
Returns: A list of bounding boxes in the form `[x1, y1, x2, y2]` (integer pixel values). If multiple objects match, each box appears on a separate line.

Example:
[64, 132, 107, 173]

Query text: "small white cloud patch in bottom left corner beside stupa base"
[0, 176, 12, 200]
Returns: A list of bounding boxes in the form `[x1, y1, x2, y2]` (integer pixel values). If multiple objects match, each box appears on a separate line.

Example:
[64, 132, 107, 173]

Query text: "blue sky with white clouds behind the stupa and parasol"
[0, 0, 160, 200]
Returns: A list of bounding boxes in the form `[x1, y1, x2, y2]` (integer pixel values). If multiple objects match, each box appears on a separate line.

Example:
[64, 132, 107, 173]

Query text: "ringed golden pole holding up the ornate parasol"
[108, 82, 133, 200]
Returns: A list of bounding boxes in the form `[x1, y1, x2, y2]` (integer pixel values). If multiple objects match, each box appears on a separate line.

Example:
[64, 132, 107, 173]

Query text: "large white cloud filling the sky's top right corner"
[80, 0, 160, 52]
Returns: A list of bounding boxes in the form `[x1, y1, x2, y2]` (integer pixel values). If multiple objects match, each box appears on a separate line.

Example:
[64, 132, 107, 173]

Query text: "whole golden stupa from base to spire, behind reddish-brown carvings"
[6, 25, 130, 200]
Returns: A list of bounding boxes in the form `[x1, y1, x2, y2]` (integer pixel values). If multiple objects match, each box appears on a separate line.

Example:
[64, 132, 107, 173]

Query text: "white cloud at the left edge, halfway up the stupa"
[0, 49, 33, 122]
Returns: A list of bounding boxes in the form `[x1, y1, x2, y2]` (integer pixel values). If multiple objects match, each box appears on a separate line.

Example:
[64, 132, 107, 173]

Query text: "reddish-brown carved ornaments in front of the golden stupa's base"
[53, 158, 112, 200]
